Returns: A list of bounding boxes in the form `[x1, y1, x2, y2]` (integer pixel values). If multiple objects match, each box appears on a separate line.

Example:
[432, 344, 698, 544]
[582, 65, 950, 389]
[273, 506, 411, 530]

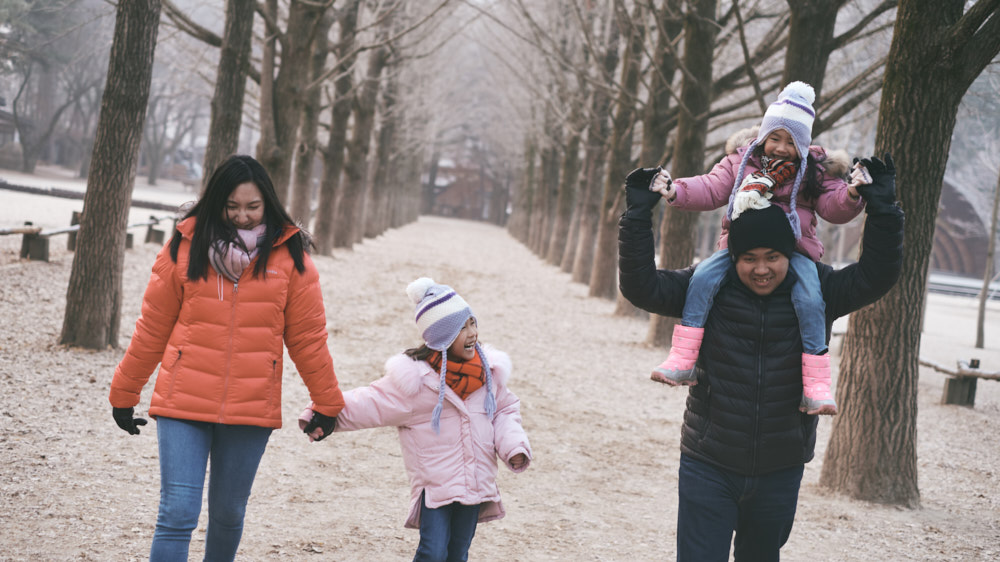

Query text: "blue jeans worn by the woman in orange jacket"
[149, 416, 271, 562]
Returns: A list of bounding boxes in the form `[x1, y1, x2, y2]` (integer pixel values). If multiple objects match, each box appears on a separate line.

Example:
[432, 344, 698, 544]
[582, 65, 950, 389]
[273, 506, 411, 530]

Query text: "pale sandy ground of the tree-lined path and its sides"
[0, 167, 1000, 561]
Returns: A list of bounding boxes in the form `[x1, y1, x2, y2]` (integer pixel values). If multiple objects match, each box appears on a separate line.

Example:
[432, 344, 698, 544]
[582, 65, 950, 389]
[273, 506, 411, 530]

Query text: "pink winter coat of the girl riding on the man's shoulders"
[670, 128, 865, 261]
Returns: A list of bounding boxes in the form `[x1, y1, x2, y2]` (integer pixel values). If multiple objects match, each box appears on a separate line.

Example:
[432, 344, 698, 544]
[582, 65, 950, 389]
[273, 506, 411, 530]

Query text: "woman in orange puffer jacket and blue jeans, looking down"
[109, 156, 344, 562]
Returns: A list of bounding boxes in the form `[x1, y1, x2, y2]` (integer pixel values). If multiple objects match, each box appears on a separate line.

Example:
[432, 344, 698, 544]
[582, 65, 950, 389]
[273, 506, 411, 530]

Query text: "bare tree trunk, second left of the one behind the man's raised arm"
[589, 3, 645, 299]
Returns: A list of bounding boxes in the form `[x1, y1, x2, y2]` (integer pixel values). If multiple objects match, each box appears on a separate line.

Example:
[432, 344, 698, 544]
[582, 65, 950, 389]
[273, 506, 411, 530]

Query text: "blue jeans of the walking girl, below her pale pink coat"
[413, 493, 479, 562]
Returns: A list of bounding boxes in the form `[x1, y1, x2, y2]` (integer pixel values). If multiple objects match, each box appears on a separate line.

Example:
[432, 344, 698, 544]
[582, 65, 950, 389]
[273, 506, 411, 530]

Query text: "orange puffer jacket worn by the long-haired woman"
[109, 218, 344, 428]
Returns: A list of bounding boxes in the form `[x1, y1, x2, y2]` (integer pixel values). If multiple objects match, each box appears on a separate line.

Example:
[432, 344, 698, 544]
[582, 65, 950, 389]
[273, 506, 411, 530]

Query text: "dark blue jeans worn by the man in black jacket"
[677, 454, 805, 562]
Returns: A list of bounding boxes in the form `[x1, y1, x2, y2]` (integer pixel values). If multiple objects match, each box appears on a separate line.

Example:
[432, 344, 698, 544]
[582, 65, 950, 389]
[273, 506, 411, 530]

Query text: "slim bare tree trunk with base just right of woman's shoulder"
[314, 0, 361, 256]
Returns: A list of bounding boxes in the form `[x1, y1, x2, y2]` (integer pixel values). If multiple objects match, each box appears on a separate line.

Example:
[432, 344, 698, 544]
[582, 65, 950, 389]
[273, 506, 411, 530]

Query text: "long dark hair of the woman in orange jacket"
[170, 155, 308, 280]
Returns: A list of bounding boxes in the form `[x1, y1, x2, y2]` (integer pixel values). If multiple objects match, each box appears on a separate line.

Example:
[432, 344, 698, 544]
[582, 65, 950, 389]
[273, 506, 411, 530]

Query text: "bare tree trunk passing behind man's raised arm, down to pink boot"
[646, 0, 718, 345]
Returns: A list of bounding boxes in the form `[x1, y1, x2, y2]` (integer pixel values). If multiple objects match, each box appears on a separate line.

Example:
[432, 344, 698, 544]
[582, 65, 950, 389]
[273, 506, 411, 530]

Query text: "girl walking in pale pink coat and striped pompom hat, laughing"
[299, 277, 531, 560]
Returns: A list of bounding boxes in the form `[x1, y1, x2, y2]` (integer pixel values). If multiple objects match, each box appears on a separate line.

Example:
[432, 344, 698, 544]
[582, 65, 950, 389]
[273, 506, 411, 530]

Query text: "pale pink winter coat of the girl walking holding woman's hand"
[335, 345, 531, 529]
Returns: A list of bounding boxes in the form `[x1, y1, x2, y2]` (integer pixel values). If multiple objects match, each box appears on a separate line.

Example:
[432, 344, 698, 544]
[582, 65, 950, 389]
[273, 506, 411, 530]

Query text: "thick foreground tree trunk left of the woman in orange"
[59, 0, 160, 349]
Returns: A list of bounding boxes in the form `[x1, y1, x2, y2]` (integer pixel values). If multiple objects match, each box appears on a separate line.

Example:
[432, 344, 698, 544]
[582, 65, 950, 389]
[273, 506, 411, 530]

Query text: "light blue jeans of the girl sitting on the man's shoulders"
[681, 250, 826, 355]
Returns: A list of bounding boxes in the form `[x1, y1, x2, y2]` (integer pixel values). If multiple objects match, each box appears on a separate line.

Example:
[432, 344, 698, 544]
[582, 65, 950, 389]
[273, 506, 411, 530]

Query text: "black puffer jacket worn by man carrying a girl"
[618, 171, 903, 475]
